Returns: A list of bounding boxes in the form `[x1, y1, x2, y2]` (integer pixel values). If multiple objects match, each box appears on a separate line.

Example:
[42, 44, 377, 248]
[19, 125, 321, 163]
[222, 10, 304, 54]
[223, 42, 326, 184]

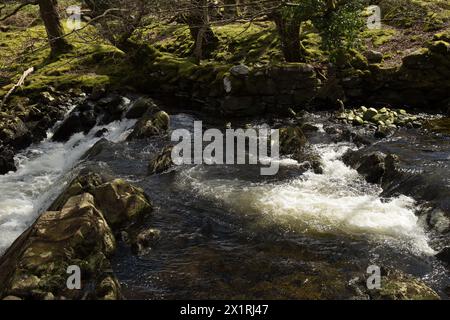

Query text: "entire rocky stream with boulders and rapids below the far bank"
[0, 94, 450, 299]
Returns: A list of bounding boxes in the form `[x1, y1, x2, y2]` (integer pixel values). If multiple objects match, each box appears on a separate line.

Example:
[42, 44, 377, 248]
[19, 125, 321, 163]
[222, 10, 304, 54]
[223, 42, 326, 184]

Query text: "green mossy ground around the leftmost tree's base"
[0, 25, 129, 96]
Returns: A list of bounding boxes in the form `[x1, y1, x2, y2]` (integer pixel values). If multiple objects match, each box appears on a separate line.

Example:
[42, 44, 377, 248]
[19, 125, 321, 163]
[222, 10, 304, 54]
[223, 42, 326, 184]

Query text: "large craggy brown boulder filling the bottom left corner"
[0, 193, 121, 299]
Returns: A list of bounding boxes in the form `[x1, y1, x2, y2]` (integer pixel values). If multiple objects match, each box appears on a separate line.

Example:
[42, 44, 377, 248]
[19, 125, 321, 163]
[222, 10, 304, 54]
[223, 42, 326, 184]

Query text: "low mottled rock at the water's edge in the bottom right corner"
[368, 270, 440, 300]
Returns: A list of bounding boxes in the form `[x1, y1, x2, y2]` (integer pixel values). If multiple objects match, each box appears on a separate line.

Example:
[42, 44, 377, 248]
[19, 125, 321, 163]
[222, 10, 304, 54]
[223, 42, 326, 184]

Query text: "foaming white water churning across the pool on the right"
[181, 144, 433, 254]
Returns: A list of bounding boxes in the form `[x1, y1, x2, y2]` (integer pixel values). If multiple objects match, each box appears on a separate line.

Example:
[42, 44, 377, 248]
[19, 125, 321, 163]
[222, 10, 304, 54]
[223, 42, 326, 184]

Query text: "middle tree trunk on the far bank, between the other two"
[186, 0, 219, 61]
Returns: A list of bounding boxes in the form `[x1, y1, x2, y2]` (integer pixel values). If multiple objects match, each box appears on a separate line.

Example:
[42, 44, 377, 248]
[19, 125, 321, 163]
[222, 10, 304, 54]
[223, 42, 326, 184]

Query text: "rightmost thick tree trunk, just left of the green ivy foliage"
[273, 12, 305, 62]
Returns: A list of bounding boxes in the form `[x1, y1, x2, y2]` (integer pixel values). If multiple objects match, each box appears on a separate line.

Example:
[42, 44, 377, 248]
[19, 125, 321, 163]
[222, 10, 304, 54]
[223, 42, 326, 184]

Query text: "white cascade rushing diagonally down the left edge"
[0, 120, 135, 255]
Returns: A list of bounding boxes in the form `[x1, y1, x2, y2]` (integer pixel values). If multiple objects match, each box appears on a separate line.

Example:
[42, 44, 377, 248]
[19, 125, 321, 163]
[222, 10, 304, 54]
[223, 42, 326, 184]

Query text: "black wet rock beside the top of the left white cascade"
[53, 106, 97, 142]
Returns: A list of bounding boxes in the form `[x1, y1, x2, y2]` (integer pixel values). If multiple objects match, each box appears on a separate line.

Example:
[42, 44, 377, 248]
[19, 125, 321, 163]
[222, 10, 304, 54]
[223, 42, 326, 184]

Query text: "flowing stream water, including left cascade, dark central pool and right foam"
[0, 114, 446, 298]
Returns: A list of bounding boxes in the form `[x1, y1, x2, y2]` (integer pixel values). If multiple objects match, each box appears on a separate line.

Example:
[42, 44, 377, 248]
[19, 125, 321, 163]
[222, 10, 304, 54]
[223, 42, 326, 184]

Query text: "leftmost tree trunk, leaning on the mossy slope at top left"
[38, 0, 72, 56]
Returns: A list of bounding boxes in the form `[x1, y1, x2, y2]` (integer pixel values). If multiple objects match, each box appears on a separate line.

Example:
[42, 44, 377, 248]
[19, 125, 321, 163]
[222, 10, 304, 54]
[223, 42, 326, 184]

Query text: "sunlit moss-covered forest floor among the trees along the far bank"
[0, 0, 450, 100]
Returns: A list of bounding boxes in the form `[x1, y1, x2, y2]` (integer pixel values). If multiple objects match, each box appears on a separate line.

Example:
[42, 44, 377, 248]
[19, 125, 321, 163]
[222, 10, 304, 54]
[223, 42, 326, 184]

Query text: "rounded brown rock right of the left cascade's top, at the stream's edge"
[128, 111, 170, 140]
